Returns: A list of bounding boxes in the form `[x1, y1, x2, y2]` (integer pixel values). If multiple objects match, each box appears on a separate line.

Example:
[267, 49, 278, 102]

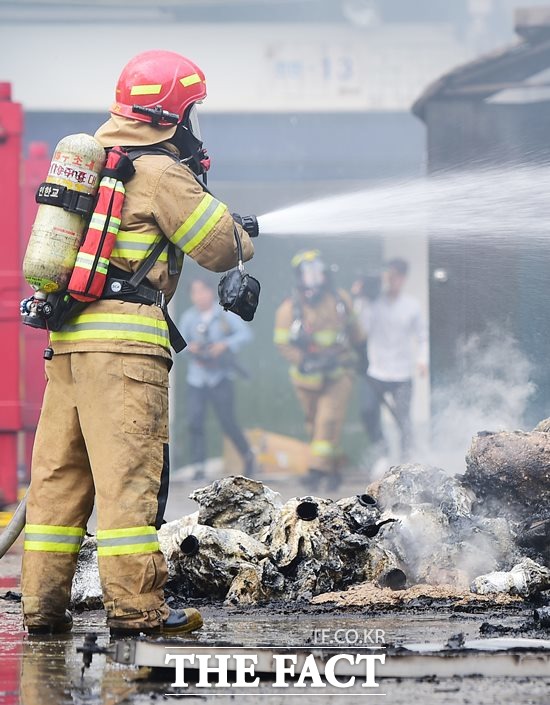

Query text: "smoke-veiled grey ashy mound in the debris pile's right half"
[369, 464, 515, 589]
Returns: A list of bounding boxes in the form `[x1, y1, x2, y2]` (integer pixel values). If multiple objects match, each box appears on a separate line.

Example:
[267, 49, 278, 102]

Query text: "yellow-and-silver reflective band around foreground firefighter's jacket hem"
[50, 313, 170, 348]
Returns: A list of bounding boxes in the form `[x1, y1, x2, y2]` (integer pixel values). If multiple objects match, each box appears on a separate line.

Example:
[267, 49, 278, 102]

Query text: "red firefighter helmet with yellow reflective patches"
[111, 50, 206, 127]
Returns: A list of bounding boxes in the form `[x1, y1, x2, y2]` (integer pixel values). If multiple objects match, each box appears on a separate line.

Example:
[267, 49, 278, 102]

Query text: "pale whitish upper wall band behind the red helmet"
[0, 18, 472, 114]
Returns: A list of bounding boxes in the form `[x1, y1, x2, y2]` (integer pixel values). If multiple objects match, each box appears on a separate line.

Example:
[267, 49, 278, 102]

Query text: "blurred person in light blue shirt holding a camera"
[180, 278, 255, 480]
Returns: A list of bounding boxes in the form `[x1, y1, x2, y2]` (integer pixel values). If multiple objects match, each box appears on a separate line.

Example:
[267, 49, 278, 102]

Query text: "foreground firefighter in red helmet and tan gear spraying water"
[22, 51, 253, 634]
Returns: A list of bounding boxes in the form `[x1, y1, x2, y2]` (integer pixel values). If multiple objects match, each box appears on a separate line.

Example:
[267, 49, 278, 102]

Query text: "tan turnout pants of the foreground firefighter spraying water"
[22, 352, 169, 628]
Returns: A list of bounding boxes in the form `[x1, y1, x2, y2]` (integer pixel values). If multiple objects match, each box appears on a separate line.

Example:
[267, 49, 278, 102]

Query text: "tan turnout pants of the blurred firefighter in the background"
[295, 374, 352, 472]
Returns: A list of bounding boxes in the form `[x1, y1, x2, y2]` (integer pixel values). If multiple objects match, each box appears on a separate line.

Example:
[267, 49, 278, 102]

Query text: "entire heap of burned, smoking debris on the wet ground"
[72, 424, 550, 607]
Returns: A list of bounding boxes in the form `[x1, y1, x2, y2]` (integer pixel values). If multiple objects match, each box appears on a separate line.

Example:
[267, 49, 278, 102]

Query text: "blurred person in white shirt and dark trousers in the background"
[357, 258, 428, 461]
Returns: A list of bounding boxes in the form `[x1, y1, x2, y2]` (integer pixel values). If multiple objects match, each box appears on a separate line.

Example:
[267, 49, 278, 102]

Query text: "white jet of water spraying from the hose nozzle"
[258, 165, 550, 244]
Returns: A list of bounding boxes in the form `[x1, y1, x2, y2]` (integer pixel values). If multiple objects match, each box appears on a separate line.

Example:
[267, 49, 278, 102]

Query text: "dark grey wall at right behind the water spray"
[426, 93, 550, 424]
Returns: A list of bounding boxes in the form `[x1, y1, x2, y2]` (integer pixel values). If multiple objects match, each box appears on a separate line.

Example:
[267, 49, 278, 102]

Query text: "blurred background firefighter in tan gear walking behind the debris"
[274, 250, 366, 490]
